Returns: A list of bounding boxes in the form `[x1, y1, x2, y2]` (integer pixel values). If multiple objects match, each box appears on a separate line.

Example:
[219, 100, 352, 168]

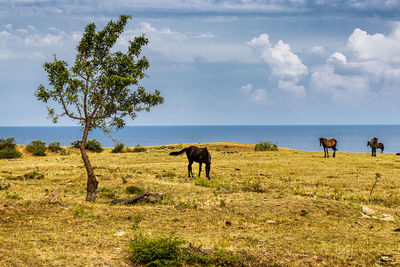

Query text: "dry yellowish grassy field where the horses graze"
[0, 143, 400, 266]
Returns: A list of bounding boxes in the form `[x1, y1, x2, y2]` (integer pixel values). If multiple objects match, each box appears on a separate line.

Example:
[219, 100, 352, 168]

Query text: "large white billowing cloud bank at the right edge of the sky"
[311, 23, 400, 105]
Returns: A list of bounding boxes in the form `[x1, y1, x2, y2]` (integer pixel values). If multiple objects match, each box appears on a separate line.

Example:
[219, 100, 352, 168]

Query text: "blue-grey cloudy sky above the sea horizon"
[0, 0, 400, 126]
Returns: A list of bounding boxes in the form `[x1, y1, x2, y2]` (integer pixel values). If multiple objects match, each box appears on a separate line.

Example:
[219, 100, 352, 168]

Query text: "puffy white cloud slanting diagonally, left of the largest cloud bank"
[247, 34, 308, 97]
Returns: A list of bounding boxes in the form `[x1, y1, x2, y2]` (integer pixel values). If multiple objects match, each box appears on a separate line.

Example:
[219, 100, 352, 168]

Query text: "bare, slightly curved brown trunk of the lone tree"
[80, 123, 99, 202]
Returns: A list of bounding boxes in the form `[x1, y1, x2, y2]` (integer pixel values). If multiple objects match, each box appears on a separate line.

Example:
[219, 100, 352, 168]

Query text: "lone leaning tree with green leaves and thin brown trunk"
[35, 15, 164, 201]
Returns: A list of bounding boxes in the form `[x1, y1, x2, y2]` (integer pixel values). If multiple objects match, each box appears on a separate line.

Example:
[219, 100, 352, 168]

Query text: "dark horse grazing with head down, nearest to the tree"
[169, 146, 211, 179]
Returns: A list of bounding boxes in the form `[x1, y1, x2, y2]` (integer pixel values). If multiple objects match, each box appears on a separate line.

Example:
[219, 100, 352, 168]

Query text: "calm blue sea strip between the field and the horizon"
[0, 125, 400, 152]
